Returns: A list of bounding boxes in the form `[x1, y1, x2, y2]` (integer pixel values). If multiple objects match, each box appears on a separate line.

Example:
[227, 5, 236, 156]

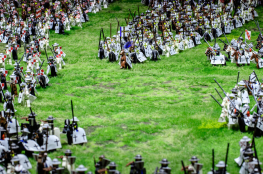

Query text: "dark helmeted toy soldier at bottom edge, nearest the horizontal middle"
[126, 155, 146, 174]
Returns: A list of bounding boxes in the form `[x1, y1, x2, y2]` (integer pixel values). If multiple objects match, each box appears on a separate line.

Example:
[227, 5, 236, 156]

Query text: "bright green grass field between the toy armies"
[1, 0, 263, 174]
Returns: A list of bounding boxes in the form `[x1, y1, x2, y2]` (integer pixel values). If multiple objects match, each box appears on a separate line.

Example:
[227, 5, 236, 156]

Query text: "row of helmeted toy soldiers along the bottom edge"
[8, 140, 262, 174]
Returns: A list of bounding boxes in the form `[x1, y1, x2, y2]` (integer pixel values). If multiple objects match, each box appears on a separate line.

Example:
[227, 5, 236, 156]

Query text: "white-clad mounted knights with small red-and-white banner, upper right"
[205, 21, 263, 69]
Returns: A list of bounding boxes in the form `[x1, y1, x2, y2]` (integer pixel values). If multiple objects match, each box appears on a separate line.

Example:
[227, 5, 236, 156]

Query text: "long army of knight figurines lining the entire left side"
[0, 0, 114, 174]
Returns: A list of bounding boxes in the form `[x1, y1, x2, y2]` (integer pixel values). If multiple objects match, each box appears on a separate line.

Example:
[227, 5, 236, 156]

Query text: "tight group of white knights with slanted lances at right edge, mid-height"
[211, 71, 263, 138]
